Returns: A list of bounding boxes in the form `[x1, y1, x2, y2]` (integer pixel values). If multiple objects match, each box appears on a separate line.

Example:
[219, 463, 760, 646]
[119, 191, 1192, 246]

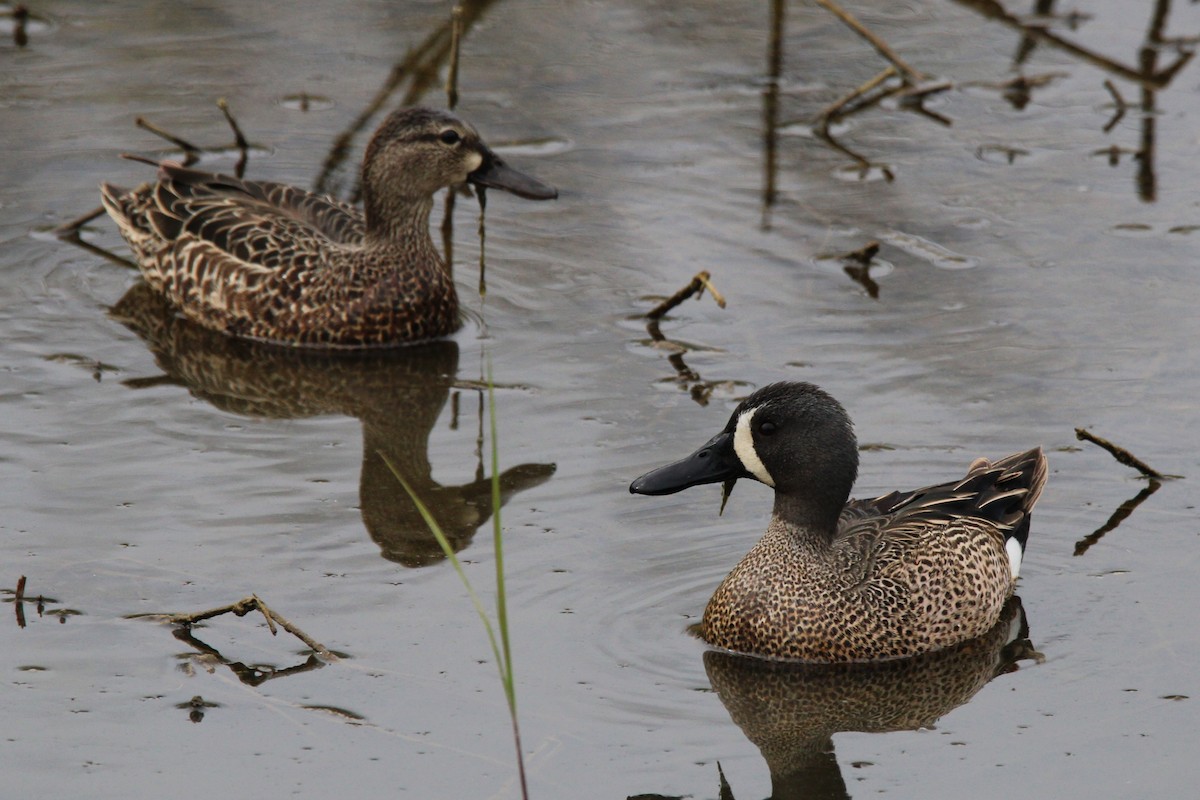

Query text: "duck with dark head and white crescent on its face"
[630, 383, 1046, 661]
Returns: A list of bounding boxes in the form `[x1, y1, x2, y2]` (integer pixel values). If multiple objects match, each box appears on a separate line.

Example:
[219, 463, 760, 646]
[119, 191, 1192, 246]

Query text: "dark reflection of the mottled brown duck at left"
[110, 282, 554, 567]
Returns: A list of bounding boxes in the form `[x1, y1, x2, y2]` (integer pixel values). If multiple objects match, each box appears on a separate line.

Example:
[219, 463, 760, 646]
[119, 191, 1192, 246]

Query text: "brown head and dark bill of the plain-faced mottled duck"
[362, 108, 558, 231]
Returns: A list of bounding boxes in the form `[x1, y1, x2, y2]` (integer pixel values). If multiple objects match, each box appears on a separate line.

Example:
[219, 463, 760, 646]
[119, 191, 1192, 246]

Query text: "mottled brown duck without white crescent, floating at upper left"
[101, 108, 557, 348]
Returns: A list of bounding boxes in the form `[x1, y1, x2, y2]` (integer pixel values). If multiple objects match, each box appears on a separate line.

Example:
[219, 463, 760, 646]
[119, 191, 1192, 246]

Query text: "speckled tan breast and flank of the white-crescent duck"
[701, 519, 1014, 661]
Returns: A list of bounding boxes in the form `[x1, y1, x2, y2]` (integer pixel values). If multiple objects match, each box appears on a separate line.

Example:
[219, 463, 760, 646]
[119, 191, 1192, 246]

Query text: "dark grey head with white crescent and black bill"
[629, 383, 858, 522]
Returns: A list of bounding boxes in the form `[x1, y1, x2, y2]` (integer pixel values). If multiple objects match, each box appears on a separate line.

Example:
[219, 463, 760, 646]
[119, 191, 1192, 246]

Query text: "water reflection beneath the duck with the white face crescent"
[704, 596, 1040, 800]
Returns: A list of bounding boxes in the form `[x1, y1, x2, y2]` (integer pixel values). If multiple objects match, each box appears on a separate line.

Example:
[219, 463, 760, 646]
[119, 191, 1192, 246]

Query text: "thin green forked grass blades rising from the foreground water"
[379, 362, 529, 800]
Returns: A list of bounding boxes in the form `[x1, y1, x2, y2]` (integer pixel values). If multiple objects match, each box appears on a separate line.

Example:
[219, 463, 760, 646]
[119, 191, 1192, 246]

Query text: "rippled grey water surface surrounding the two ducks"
[0, 0, 1200, 798]
